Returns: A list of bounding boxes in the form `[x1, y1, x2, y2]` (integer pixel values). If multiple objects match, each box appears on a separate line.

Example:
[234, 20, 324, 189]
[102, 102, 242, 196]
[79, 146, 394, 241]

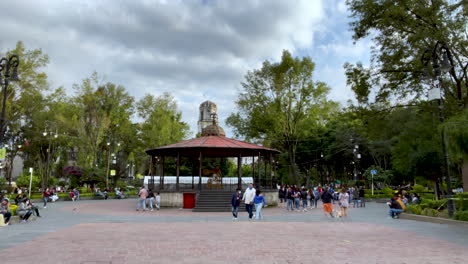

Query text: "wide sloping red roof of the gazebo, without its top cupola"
[146, 136, 279, 157]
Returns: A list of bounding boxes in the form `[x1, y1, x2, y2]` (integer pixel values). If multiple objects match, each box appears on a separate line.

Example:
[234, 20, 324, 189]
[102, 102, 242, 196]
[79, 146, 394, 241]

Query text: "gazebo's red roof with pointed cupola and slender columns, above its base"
[146, 114, 279, 191]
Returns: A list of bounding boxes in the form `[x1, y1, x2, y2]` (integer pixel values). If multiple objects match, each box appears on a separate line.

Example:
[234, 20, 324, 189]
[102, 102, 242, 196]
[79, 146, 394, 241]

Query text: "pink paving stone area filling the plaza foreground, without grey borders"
[0, 222, 468, 264]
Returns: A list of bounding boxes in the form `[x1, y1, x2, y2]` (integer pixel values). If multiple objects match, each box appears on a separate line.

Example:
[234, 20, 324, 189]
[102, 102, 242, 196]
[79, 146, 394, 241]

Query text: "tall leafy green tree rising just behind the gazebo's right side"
[227, 51, 336, 184]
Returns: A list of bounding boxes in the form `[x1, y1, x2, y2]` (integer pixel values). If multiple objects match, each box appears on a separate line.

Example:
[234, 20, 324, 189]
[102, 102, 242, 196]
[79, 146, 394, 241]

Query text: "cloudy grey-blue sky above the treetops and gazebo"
[0, 0, 371, 136]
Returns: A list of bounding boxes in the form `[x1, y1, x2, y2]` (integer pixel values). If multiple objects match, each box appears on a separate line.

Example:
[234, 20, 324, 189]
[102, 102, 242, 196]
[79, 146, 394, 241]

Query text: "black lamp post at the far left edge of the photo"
[0, 54, 19, 144]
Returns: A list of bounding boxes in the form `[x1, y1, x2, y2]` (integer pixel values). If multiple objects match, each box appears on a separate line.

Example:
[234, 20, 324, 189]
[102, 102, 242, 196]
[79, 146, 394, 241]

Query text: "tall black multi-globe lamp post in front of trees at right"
[421, 42, 455, 217]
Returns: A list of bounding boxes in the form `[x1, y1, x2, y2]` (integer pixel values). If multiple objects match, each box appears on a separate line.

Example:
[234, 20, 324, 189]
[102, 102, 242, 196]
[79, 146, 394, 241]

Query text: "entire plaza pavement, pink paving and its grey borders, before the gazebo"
[0, 199, 468, 264]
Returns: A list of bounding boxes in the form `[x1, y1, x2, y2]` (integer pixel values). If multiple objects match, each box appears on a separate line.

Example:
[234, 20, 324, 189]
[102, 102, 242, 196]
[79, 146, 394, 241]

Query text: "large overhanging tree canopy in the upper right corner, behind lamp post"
[346, 0, 468, 107]
